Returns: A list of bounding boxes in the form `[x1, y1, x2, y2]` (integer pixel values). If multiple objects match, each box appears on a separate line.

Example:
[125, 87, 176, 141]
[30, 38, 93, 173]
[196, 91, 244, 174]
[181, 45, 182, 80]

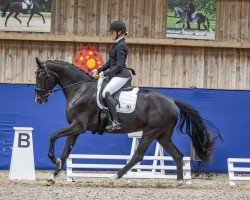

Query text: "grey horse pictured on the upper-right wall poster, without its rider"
[174, 7, 212, 35]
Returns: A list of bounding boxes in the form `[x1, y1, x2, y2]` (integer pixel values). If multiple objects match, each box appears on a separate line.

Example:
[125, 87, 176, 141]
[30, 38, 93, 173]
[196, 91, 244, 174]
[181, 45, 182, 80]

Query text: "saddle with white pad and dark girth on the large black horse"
[96, 77, 139, 135]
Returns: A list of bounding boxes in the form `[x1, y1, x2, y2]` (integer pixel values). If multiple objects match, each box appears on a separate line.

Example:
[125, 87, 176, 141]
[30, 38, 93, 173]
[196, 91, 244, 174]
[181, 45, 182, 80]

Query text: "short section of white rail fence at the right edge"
[227, 158, 250, 185]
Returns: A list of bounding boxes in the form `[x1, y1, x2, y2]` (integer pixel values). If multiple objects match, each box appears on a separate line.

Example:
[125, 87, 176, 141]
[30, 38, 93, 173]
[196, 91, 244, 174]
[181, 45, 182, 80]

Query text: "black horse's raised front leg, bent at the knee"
[48, 122, 85, 169]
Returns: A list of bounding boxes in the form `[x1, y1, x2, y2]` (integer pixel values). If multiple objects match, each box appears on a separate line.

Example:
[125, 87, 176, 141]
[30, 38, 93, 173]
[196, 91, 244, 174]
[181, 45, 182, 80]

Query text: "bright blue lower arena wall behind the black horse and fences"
[0, 84, 250, 172]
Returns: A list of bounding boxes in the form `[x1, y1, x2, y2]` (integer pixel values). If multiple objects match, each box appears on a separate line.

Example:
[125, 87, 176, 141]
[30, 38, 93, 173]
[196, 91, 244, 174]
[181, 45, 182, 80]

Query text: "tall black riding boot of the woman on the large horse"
[105, 92, 121, 131]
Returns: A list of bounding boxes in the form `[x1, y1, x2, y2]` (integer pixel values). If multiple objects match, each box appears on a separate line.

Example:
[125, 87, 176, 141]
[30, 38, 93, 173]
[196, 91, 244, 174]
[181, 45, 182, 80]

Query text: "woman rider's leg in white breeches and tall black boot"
[102, 77, 129, 131]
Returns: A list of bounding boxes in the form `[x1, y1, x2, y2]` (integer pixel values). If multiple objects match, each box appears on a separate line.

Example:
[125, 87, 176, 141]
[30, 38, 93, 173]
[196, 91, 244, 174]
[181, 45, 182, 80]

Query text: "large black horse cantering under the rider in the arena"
[35, 58, 220, 184]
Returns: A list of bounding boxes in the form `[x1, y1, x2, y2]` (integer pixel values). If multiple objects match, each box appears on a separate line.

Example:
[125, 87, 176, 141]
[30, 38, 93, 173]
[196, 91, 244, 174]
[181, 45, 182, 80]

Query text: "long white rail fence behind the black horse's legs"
[67, 132, 191, 184]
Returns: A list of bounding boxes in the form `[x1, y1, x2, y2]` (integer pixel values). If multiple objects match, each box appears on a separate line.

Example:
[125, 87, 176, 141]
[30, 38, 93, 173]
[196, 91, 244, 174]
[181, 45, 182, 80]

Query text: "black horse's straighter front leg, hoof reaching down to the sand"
[47, 134, 79, 185]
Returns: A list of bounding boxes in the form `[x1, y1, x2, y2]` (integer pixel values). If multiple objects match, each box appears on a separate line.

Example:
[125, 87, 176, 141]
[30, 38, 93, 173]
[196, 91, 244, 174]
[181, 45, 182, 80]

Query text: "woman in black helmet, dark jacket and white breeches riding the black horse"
[92, 21, 131, 131]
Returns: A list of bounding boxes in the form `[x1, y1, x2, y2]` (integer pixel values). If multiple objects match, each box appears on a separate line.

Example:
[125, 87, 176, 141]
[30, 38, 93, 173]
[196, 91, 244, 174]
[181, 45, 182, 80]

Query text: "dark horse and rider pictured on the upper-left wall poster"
[2, 0, 48, 26]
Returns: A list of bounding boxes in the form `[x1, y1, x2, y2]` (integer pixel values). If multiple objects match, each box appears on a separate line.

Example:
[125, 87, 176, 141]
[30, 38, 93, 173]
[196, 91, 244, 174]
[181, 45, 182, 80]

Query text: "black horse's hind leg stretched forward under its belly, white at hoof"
[112, 129, 158, 179]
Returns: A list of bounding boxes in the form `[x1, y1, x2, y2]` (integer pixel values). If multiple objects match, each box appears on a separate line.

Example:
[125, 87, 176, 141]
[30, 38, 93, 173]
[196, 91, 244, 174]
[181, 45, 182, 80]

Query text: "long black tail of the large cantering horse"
[175, 100, 222, 162]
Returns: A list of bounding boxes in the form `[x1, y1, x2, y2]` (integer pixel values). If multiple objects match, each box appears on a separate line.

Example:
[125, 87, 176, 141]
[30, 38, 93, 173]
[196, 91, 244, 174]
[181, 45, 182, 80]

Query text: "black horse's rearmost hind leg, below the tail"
[156, 134, 183, 180]
